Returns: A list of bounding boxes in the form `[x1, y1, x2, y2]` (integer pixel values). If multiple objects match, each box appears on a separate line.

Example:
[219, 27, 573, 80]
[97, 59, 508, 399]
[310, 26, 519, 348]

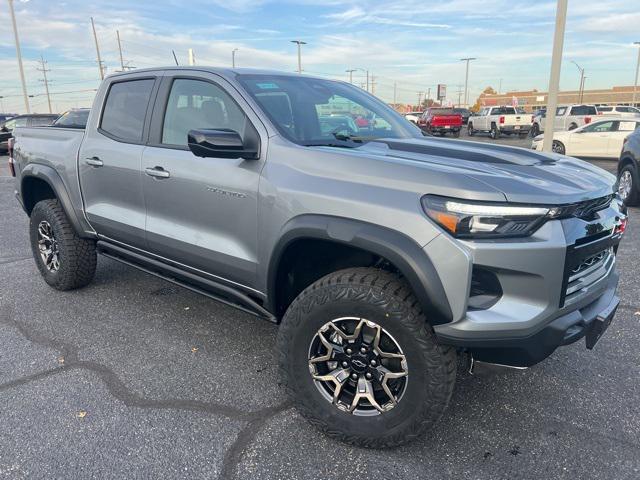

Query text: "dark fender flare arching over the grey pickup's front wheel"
[267, 214, 453, 324]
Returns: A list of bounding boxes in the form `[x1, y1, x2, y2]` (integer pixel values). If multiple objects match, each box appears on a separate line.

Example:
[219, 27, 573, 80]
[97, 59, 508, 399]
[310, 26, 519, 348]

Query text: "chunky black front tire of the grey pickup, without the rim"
[278, 268, 457, 448]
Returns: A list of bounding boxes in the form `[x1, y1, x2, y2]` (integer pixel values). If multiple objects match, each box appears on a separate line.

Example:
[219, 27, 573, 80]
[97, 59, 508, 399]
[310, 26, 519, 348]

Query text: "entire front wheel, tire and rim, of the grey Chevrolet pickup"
[278, 268, 456, 448]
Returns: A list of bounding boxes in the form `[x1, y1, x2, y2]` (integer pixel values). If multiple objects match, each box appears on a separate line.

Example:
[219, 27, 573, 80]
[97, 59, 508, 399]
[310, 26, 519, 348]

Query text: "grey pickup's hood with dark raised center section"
[355, 138, 616, 205]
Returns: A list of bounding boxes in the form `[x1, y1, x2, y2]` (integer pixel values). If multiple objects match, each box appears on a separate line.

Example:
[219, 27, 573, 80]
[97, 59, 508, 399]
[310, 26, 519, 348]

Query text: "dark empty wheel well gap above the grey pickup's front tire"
[273, 238, 398, 318]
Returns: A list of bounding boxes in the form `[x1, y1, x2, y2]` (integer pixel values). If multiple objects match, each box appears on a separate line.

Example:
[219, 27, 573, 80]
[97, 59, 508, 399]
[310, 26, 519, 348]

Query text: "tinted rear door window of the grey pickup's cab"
[100, 79, 154, 142]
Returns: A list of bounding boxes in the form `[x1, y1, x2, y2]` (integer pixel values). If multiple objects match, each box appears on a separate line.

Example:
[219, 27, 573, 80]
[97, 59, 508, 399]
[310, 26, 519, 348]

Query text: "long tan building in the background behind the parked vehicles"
[479, 86, 640, 112]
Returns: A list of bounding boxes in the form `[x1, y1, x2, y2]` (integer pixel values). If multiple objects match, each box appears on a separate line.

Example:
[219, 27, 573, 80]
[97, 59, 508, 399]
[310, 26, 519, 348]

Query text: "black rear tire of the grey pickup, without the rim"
[29, 199, 97, 290]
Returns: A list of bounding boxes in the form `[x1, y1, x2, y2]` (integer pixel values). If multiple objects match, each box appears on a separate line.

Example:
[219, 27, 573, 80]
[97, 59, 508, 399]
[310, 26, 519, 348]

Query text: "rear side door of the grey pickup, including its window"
[78, 75, 156, 248]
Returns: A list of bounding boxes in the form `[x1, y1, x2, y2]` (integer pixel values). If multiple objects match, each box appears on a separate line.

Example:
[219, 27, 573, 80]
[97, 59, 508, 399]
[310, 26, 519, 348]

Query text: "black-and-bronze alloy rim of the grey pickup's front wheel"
[309, 317, 409, 416]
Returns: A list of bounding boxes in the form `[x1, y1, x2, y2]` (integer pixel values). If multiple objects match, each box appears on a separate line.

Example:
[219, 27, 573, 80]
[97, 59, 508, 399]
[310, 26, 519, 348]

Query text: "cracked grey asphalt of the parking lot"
[0, 143, 640, 479]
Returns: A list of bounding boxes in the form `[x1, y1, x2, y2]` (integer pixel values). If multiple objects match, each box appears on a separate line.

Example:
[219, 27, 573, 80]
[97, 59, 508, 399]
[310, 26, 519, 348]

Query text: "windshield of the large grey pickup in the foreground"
[238, 74, 422, 147]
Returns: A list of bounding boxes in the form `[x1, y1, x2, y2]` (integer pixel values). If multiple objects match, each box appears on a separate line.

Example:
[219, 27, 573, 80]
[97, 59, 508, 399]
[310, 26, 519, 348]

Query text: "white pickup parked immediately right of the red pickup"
[467, 106, 531, 138]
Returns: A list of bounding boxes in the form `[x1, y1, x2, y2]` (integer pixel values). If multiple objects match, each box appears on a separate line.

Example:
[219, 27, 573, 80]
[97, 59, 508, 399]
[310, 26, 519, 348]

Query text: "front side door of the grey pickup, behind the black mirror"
[142, 71, 267, 290]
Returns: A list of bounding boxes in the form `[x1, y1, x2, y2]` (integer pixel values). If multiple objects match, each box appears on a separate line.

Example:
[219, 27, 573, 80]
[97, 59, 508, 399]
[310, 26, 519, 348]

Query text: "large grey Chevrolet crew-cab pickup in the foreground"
[10, 67, 627, 447]
